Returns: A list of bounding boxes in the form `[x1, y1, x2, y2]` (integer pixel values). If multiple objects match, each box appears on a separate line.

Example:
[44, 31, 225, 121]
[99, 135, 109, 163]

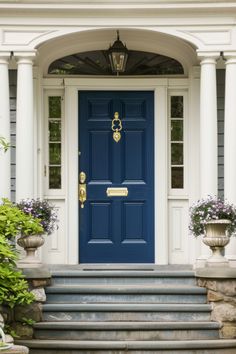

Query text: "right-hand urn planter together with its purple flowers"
[189, 196, 236, 265]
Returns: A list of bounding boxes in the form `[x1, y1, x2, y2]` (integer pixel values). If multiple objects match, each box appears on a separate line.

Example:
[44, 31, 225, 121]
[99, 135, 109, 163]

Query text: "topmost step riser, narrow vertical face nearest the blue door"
[52, 277, 196, 286]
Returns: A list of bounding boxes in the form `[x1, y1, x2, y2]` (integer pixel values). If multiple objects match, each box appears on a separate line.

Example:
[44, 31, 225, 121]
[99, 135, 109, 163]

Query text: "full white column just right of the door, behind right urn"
[196, 53, 220, 266]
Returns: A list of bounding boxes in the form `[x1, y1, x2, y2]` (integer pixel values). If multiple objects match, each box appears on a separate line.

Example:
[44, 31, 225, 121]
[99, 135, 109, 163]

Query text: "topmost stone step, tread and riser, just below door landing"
[52, 268, 196, 285]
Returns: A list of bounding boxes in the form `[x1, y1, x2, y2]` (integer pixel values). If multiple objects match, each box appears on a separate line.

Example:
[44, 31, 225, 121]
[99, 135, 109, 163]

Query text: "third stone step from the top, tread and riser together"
[43, 303, 211, 322]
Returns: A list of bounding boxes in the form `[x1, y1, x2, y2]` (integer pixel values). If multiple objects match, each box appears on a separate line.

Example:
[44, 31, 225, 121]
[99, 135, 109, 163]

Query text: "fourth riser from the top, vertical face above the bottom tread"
[34, 328, 219, 340]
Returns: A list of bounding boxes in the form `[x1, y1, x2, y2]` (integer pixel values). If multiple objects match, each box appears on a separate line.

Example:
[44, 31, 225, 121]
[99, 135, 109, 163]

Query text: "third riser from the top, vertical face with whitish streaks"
[43, 311, 210, 322]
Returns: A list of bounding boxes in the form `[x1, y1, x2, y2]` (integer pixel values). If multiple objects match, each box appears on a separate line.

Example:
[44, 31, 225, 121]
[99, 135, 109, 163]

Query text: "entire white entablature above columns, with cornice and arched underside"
[0, 0, 236, 52]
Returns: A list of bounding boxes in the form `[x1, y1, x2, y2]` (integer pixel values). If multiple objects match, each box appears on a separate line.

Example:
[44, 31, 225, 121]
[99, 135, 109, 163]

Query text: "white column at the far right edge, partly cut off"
[224, 52, 236, 266]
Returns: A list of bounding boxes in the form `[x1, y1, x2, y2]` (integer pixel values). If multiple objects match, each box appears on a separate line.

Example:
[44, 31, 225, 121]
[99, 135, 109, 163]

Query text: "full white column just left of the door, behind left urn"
[14, 53, 35, 201]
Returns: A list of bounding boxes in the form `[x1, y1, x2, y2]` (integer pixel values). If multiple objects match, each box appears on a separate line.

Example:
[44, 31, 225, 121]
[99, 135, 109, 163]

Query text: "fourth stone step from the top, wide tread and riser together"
[34, 322, 221, 341]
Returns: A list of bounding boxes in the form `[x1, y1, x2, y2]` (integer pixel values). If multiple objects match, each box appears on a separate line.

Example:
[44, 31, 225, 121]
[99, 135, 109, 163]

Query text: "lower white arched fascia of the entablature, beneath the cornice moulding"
[0, 27, 236, 51]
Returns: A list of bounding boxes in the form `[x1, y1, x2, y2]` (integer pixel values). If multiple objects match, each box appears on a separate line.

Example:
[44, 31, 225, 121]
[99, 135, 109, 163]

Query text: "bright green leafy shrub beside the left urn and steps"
[0, 199, 39, 308]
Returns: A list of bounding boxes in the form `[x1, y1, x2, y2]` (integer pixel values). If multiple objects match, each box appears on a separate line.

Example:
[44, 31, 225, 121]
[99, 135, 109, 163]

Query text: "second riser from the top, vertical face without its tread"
[47, 294, 206, 304]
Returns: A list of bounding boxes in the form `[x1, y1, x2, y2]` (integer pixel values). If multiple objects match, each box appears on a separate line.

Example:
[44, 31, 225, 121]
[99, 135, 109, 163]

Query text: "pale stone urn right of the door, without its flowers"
[203, 220, 231, 266]
